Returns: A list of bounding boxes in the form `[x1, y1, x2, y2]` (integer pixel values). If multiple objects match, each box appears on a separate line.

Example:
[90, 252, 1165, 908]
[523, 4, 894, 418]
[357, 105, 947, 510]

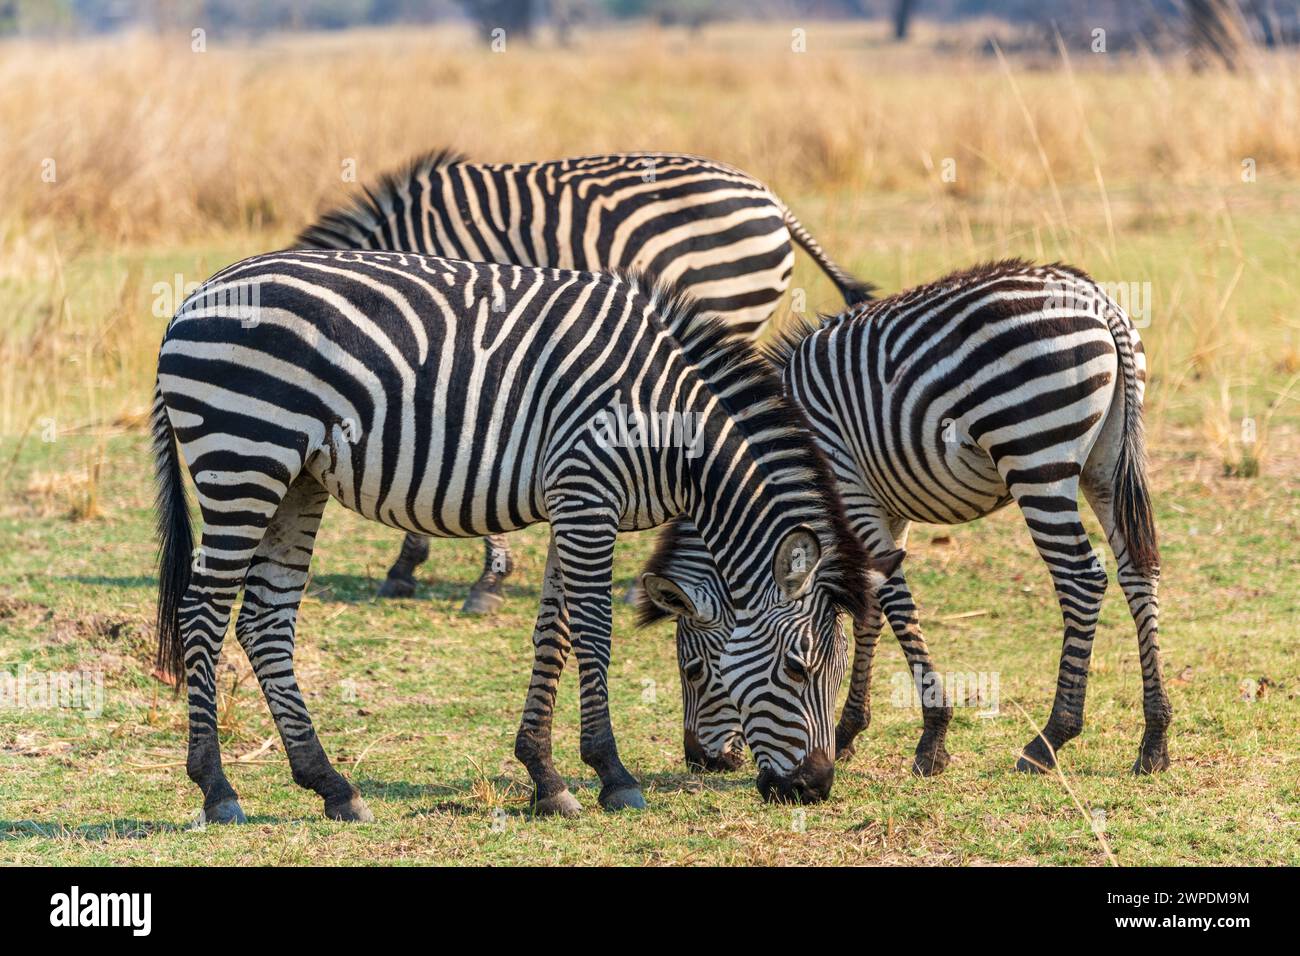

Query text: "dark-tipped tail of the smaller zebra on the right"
[1106, 304, 1160, 575]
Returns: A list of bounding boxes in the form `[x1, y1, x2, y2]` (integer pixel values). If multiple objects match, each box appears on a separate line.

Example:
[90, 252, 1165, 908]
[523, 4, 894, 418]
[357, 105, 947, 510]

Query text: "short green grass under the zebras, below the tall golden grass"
[0, 195, 1300, 865]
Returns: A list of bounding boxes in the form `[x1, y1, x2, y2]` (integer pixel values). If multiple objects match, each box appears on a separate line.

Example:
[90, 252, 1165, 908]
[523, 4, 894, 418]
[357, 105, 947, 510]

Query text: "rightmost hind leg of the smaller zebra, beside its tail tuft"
[1083, 481, 1174, 774]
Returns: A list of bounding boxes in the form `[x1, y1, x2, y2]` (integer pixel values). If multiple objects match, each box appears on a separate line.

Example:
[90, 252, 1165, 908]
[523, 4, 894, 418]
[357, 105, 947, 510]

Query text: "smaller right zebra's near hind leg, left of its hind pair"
[1000, 476, 1106, 773]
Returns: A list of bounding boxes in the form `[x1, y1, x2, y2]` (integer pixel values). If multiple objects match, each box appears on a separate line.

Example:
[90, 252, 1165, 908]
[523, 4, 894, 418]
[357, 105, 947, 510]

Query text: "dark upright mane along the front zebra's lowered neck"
[621, 272, 868, 623]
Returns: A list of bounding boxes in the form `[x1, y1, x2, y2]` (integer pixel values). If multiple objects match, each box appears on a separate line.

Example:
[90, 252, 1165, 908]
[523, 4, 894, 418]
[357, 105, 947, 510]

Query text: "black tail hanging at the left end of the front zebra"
[151, 385, 194, 691]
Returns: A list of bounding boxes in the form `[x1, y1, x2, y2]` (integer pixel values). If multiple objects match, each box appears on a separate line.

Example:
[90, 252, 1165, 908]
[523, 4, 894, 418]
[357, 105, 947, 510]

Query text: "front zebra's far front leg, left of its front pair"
[515, 535, 582, 817]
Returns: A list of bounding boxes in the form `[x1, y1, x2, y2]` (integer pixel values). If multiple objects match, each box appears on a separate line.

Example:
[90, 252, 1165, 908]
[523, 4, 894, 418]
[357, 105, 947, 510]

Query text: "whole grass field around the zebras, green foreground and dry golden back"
[0, 20, 1300, 865]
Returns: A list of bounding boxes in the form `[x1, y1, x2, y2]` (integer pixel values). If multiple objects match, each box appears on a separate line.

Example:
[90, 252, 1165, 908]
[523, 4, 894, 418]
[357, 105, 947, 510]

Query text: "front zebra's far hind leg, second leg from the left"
[235, 475, 374, 821]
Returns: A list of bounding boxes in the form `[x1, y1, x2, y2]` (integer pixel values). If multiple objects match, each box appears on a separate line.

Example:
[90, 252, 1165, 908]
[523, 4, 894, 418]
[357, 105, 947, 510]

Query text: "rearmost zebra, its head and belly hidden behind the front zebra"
[296, 151, 871, 613]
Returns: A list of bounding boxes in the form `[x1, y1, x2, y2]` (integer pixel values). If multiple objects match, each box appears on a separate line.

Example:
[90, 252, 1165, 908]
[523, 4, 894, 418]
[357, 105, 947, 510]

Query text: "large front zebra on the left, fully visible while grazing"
[152, 251, 866, 821]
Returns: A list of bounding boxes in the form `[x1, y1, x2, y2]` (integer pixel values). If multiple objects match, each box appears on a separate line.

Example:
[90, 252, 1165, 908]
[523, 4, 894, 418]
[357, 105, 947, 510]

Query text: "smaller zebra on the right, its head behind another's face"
[641, 260, 1173, 775]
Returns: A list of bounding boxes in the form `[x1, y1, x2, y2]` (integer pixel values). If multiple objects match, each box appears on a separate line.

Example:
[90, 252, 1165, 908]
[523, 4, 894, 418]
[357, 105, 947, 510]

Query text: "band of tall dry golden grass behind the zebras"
[0, 23, 1300, 239]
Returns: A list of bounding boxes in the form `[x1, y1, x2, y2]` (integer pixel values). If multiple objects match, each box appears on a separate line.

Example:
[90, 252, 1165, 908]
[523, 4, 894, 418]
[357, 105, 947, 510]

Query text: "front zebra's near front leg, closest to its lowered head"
[551, 510, 646, 810]
